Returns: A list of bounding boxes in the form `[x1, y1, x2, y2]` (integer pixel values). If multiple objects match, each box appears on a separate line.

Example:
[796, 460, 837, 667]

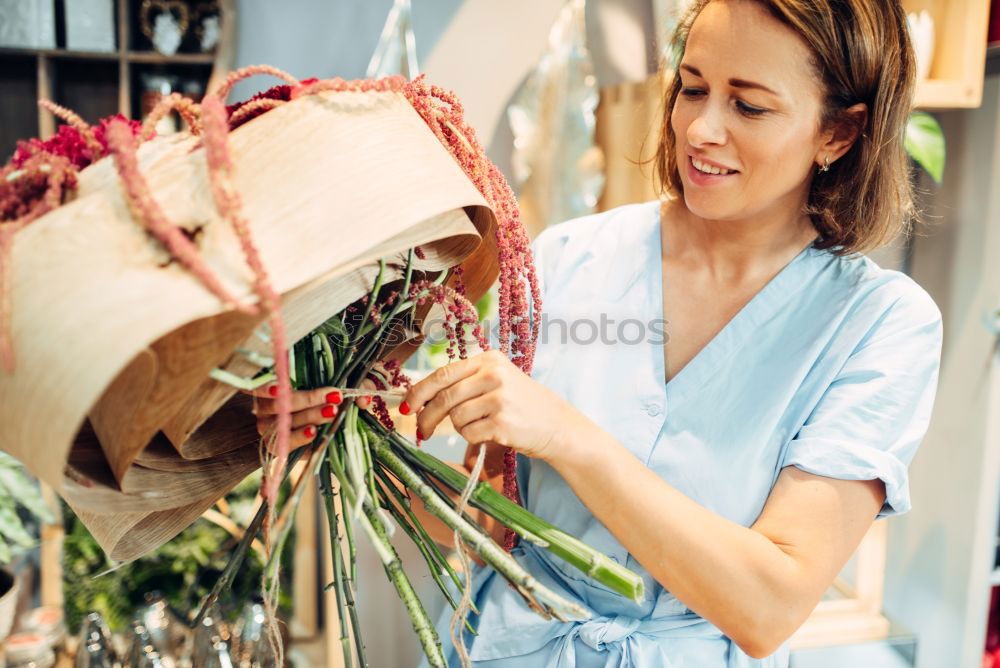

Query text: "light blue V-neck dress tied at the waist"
[421, 201, 942, 668]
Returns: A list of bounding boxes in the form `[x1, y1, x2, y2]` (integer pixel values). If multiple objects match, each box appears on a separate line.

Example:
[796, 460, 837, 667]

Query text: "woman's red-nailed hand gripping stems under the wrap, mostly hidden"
[240, 380, 375, 450]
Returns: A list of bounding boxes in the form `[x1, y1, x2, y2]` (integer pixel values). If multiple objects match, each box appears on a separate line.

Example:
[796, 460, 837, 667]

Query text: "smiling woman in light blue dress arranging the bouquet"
[252, 0, 942, 668]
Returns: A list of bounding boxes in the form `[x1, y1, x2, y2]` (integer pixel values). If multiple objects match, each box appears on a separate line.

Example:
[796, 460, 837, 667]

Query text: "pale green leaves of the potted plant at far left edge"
[0, 452, 54, 565]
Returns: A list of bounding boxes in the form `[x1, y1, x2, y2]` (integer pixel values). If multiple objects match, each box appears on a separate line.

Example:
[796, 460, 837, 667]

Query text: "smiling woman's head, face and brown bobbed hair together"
[654, 0, 915, 254]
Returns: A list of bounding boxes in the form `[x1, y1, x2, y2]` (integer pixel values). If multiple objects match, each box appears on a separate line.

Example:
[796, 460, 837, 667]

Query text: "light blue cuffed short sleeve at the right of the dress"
[781, 279, 942, 519]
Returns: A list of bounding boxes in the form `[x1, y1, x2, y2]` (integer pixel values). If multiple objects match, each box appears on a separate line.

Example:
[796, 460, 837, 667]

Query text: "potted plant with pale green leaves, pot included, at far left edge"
[0, 452, 54, 642]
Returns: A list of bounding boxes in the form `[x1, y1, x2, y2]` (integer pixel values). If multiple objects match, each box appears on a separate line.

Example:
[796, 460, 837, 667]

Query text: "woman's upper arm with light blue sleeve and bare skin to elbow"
[752, 280, 943, 645]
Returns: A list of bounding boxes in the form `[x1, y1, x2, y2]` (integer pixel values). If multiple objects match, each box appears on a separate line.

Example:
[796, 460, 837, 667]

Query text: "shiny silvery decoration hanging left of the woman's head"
[507, 0, 604, 236]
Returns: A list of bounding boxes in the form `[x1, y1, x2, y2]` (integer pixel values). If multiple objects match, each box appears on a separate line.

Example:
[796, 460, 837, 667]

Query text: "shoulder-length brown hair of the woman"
[653, 0, 916, 255]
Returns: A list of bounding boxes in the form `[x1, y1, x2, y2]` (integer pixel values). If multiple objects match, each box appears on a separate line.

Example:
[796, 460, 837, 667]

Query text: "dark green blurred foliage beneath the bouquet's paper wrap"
[63, 471, 294, 633]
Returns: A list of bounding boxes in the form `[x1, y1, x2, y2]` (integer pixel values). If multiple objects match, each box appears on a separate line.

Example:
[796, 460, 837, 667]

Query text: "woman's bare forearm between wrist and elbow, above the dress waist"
[549, 420, 800, 654]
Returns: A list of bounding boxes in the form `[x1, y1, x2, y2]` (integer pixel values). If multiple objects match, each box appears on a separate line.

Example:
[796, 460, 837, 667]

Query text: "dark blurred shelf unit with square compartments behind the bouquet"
[0, 0, 236, 163]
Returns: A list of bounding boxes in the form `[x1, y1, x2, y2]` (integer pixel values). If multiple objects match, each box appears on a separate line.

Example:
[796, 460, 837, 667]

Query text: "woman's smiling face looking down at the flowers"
[670, 0, 823, 220]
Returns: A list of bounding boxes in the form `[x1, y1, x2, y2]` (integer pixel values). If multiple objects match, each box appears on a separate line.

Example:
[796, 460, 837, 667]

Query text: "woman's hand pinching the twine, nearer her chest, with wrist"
[400, 350, 581, 459]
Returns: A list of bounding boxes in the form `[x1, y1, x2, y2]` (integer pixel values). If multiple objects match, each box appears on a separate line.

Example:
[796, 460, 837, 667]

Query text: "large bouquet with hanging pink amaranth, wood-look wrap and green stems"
[0, 66, 642, 666]
